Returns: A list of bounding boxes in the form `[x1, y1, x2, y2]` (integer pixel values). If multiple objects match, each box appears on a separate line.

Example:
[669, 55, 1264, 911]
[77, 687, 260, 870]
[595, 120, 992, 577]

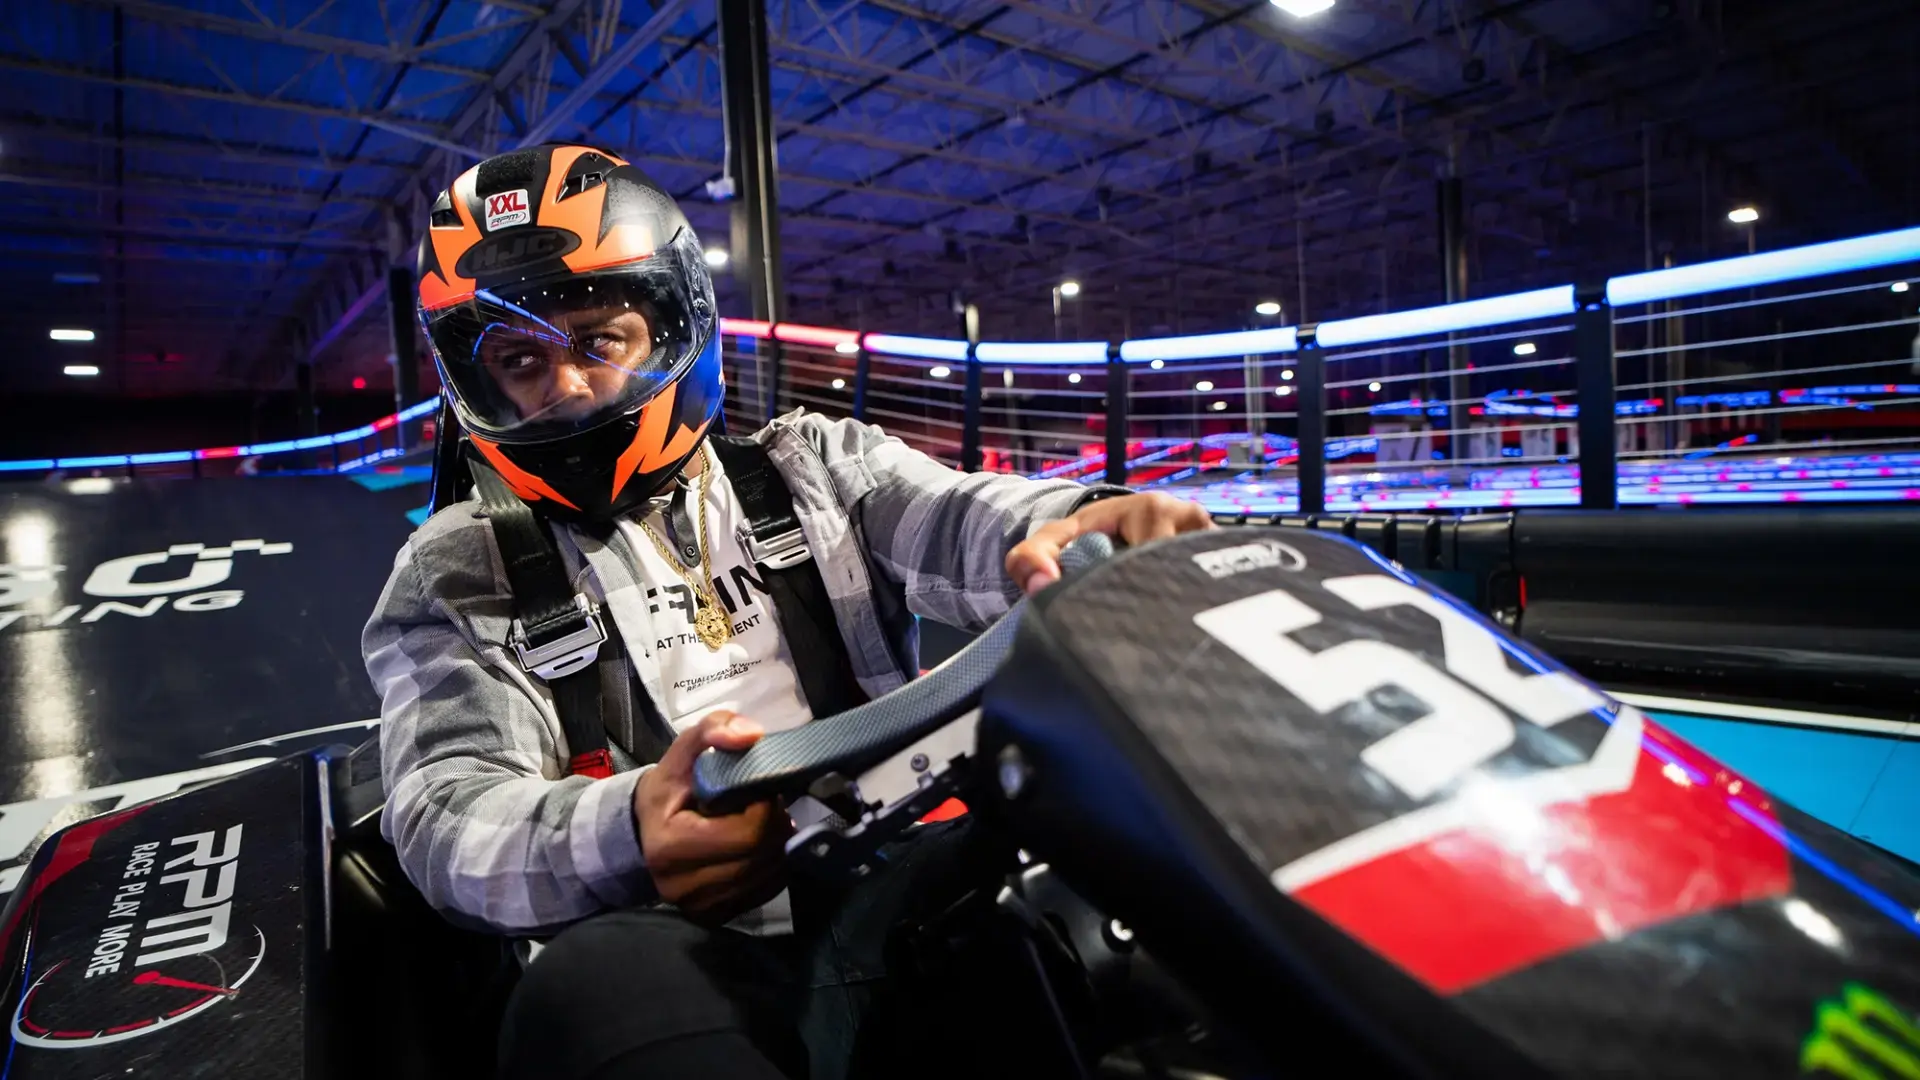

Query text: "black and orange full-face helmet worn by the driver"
[419, 146, 724, 521]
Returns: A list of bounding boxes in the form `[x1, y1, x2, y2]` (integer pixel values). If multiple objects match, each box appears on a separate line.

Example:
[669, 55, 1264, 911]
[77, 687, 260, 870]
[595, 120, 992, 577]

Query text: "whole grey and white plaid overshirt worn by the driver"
[361, 413, 1112, 934]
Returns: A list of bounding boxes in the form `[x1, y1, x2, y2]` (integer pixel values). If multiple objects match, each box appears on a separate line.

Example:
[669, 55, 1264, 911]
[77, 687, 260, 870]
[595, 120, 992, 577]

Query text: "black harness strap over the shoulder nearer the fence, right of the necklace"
[707, 436, 866, 717]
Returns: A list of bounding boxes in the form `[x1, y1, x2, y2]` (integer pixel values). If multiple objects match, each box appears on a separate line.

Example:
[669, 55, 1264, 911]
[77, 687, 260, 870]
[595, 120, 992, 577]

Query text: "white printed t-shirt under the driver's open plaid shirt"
[620, 445, 812, 732]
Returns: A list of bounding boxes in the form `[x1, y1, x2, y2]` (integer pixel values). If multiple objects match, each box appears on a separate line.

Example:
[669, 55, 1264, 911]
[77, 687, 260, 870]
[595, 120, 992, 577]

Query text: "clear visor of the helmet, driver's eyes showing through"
[426, 231, 714, 442]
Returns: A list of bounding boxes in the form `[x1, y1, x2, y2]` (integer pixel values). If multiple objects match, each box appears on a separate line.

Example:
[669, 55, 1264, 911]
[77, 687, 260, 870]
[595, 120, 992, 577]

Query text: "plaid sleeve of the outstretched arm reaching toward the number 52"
[806, 417, 1125, 630]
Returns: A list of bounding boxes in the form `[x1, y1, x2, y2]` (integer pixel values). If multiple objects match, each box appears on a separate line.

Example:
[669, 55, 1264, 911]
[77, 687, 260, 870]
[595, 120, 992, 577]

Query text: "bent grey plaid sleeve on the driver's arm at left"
[361, 511, 653, 934]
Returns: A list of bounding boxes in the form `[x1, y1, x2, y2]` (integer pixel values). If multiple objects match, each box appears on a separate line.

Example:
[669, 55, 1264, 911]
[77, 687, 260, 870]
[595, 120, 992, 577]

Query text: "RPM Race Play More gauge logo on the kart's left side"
[12, 824, 267, 1049]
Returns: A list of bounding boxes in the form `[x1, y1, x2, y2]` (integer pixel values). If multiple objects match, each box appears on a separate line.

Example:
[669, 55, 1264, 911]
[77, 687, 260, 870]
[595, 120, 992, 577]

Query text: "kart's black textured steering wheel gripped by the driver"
[693, 532, 1114, 871]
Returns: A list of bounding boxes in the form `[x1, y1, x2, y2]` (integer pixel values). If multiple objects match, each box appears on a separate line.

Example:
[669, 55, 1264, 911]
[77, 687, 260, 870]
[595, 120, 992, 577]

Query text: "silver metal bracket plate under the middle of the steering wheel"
[787, 709, 979, 878]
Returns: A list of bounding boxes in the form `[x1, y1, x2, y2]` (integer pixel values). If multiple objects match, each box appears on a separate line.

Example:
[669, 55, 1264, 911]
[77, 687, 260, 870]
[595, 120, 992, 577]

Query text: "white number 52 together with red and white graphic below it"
[1192, 575, 1791, 992]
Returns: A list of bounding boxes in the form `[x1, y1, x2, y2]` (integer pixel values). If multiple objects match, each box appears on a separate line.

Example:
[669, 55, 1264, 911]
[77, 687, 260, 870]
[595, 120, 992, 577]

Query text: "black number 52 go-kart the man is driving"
[0, 528, 1920, 1080]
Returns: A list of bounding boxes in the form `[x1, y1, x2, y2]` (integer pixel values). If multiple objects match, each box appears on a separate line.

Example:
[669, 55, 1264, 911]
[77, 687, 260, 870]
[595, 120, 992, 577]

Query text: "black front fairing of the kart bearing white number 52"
[975, 528, 1920, 1078]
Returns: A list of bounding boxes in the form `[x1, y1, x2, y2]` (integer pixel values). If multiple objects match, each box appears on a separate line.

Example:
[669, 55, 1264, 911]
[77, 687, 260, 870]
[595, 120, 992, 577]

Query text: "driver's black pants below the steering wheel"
[499, 819, 993, 1080]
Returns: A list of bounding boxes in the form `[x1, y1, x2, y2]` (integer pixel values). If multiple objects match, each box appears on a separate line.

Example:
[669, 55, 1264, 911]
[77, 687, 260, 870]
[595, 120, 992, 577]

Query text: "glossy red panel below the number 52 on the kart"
[1290, 723, 1793, 994]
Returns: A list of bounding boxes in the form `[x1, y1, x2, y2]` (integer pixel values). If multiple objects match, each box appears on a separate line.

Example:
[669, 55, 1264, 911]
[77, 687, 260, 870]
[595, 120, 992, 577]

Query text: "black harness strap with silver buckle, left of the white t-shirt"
[470, 461, 664, 776]
